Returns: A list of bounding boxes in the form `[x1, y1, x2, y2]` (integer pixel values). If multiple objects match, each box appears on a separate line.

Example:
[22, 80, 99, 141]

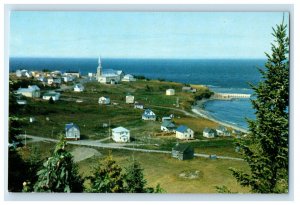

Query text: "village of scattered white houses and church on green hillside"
[10, 58, 248, 192]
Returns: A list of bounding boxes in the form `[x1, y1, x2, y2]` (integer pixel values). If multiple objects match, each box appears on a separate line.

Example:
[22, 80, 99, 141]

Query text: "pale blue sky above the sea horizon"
[9, 11, 288, 59]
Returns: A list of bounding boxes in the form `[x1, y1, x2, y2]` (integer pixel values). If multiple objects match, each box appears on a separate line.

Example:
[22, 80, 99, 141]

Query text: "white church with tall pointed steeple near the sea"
[96, 57, 124, 84]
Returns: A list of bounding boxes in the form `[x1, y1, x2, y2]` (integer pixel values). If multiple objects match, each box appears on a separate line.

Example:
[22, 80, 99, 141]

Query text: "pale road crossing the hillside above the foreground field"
[20, 135, 243, 161]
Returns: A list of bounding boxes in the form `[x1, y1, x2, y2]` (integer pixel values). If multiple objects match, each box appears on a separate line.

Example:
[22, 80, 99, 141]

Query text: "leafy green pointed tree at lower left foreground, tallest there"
[34, 136, 83, 193]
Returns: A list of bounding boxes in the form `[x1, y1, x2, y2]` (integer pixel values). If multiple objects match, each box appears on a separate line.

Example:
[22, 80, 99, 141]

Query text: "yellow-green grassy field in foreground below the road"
[23, 142, 249, 193]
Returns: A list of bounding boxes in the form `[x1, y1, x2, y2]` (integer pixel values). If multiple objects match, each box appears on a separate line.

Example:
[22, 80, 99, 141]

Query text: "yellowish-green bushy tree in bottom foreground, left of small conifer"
[88, 155, 125, 193]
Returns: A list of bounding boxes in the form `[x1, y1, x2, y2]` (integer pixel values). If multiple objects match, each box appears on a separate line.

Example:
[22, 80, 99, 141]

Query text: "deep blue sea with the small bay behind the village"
[9, 58, 265, 129]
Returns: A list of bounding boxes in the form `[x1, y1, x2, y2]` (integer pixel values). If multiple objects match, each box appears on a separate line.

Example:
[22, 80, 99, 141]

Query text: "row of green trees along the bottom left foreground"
[8, 137, 164, 193]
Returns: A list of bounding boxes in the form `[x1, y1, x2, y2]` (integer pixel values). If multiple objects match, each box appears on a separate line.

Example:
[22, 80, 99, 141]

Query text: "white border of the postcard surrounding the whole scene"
[0, 0, 299, 203]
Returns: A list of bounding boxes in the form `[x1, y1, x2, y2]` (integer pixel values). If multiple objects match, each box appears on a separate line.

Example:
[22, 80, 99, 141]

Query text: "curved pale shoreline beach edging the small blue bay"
[192, 99, 249, 133]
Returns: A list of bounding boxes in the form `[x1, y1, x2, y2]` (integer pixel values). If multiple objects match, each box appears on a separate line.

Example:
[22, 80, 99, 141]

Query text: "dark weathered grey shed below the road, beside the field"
[172, 143, 194, 160]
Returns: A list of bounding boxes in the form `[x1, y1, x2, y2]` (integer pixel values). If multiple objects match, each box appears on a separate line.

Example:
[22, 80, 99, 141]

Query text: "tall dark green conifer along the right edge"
[231, 18, 289, 193]
